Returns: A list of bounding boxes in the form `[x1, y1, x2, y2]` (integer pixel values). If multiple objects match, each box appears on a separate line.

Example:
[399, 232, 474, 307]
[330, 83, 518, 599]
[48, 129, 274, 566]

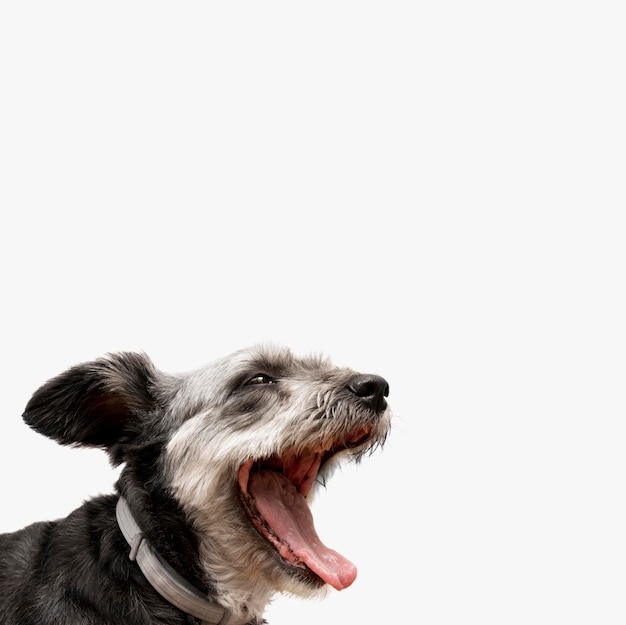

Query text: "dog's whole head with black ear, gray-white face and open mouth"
[25, 347, 391, 611]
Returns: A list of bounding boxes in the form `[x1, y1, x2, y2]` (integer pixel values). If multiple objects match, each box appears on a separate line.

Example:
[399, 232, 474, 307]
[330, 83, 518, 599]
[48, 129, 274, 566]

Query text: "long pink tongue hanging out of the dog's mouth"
[248, 471, 356, 590]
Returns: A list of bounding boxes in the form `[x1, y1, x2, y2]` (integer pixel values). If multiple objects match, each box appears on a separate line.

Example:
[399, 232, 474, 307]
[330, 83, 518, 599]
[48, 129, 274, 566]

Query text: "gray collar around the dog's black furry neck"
[115, 497, 249, 625]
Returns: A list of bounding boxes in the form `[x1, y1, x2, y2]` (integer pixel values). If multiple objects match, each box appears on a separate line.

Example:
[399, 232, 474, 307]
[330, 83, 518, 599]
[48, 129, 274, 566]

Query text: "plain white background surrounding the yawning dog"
[0, 0, 626, 625]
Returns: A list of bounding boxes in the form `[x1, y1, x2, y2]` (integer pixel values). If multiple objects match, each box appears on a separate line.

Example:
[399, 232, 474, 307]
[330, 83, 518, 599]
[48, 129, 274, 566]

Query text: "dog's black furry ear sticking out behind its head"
[23, 352, 158, 463]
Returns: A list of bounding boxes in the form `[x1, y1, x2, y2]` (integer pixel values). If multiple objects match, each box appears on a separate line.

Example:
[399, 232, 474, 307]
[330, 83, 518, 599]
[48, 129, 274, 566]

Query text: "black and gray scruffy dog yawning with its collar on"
[0, 345, 391, 625]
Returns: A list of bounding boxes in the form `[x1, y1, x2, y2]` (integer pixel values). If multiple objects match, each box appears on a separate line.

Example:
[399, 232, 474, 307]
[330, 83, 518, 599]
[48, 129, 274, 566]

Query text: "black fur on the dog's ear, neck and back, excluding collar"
[0, 354, 212, 625]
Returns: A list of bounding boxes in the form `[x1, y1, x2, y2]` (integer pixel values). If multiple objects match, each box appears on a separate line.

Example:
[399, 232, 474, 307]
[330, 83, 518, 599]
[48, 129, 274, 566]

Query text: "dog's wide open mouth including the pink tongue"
[238, 427, 371, 590]
